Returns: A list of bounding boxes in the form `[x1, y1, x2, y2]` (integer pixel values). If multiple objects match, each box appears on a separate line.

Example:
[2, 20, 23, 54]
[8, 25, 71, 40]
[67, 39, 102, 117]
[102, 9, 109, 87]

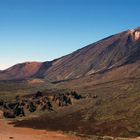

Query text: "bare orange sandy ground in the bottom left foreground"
[0, 112, 81, 140]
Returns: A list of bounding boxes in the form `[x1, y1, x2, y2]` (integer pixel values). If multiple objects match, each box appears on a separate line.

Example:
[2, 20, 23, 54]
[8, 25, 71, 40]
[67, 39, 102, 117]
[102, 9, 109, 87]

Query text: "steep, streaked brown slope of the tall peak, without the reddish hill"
[38, 28, 140, 80]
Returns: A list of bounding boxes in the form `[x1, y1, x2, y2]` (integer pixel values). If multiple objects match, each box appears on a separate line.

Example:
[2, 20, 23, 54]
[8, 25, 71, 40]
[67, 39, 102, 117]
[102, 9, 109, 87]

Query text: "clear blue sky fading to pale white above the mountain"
[0, 0, 140, 69]
